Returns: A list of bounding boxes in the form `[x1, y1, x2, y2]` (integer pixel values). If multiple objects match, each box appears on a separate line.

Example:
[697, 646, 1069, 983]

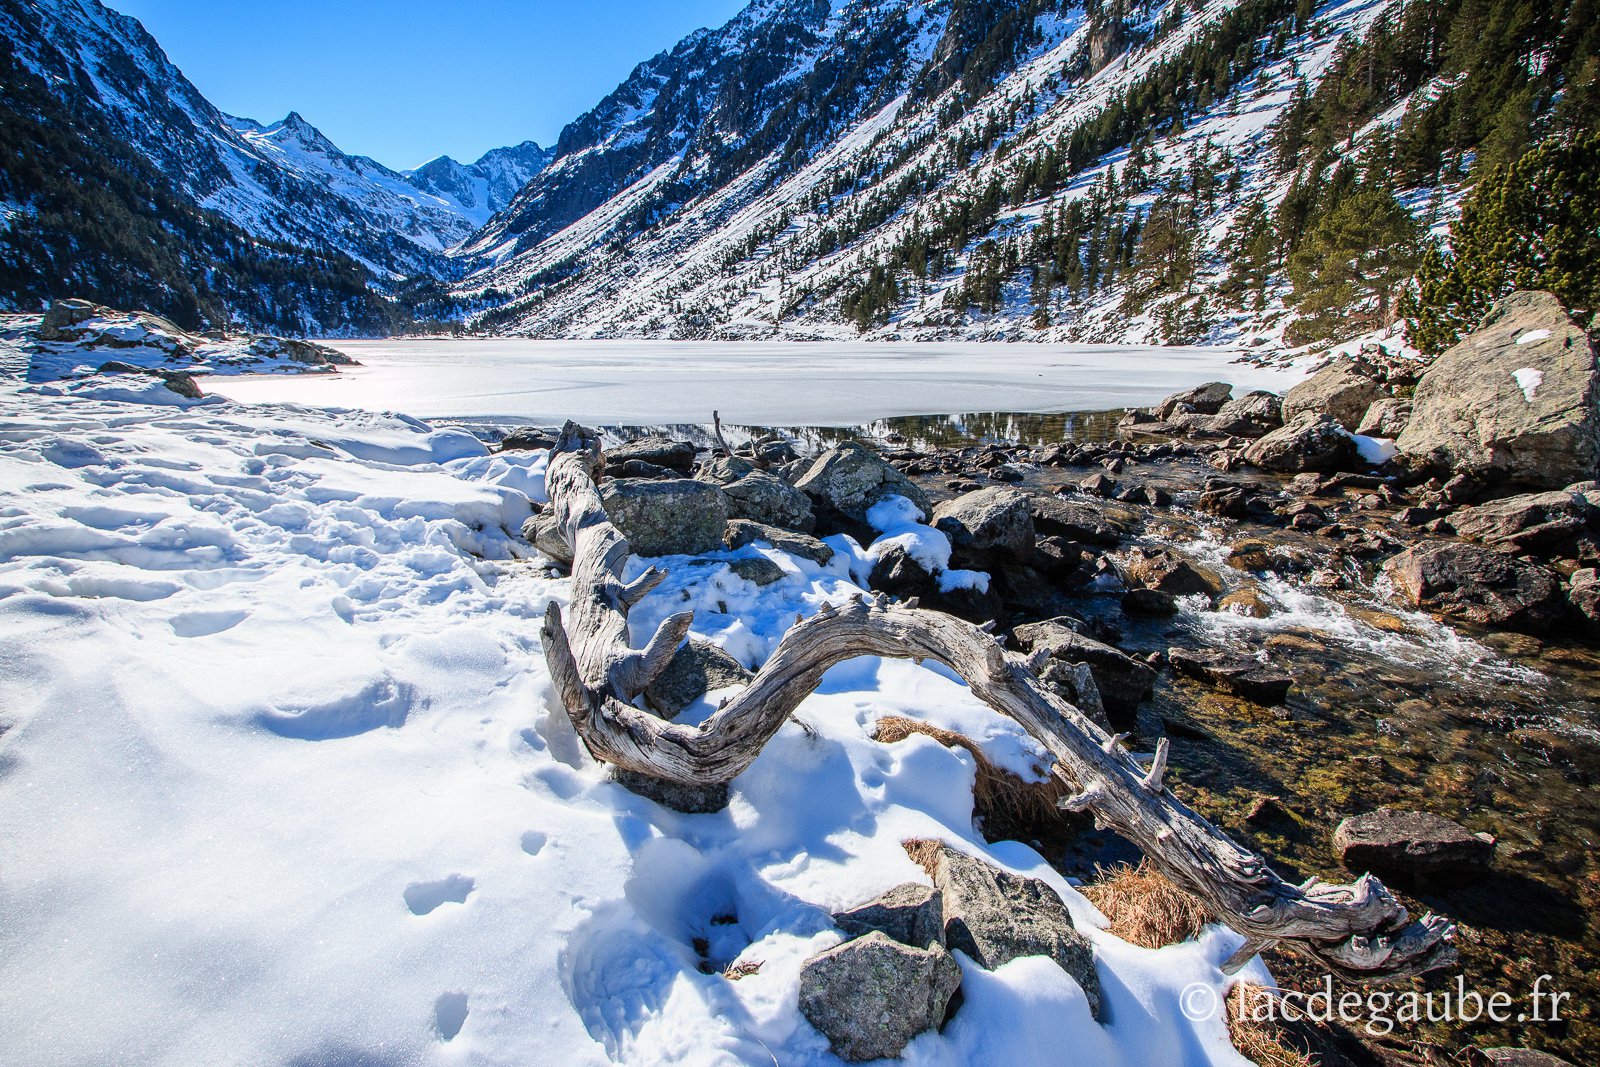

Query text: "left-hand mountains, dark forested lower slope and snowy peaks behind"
[0, 0, 544, 333]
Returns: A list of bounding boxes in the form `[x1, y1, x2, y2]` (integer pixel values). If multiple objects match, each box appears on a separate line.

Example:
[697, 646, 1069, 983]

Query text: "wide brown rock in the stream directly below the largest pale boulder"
[1384, 541, 1566, 633]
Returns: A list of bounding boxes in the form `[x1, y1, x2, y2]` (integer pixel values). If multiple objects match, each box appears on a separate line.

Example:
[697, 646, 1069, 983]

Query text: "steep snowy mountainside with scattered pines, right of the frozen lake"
[451, 0, 1600, 344]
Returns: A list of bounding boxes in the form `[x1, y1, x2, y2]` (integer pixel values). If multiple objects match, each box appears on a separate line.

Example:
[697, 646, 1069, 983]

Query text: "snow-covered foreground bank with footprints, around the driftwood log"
[0, 379, 1266, 1067]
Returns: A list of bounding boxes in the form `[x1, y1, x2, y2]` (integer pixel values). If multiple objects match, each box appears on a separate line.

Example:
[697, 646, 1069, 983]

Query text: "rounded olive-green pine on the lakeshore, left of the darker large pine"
[1288, 186, 1421, 341]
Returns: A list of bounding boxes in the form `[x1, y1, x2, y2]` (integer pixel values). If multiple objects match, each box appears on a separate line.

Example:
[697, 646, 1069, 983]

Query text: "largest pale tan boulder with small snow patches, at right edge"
[1395, 293, 1600, 490]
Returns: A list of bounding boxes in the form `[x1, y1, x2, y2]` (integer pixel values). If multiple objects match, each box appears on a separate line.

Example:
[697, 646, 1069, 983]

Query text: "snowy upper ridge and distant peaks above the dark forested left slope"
[0, 0, 544, 282]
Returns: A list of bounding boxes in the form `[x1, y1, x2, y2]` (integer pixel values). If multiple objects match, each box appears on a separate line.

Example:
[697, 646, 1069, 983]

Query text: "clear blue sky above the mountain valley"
[107, 0, 747, 170]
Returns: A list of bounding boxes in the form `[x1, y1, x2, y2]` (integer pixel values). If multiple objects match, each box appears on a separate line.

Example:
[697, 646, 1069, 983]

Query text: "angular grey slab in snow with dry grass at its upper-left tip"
[931, 845, 1101, 1019]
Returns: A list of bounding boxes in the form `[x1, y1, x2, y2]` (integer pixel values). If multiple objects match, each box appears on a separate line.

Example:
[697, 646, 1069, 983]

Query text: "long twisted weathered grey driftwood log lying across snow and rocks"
[542, 424, 1456, 981]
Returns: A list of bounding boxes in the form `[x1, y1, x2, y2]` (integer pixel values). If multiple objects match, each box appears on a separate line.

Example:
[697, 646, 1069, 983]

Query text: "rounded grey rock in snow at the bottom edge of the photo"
[800, 931, 962, 1062]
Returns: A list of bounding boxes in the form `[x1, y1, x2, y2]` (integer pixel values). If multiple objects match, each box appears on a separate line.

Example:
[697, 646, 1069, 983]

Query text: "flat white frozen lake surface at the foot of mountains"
[205, 339, 1302, 426]
